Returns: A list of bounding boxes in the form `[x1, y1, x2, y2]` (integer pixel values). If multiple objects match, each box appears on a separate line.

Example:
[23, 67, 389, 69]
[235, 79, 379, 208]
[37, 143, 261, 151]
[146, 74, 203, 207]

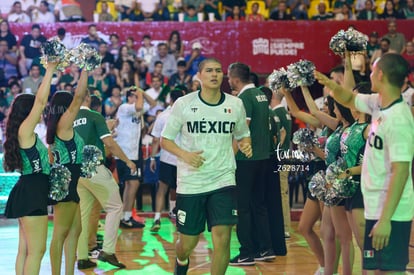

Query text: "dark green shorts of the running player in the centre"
[176, 189, 238, 236]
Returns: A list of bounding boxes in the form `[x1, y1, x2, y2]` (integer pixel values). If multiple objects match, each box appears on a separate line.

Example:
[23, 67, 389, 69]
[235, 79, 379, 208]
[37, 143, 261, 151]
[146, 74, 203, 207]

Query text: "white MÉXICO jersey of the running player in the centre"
[161, 92, 250, 195]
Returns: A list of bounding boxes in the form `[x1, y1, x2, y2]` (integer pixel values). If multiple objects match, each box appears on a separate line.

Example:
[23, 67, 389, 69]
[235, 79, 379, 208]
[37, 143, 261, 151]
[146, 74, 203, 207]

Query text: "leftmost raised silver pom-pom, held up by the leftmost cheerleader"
[40, 39, 69, 71]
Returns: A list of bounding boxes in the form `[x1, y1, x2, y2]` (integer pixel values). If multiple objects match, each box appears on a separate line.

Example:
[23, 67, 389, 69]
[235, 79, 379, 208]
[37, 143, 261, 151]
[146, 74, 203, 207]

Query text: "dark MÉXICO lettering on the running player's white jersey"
[187, 120, 236, 134]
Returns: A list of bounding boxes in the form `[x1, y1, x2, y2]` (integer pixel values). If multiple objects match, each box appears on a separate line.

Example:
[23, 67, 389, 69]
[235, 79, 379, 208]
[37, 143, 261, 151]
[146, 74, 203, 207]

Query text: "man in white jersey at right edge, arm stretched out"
[315, 53, 414, 274]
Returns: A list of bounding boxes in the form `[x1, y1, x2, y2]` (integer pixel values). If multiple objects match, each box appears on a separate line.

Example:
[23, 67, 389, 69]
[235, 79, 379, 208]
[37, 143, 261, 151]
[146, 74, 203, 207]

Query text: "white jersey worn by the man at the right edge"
[355, 94, 414, 221]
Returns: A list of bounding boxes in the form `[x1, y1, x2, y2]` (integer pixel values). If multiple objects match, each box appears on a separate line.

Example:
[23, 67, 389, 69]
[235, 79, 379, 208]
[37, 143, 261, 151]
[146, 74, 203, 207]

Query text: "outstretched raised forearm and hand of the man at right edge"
[315, 71, 356, 109]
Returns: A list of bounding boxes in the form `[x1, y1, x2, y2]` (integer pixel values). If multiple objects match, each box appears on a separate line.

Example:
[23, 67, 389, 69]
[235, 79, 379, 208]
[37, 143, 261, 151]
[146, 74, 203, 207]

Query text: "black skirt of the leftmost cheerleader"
[4, 173, 49, 219]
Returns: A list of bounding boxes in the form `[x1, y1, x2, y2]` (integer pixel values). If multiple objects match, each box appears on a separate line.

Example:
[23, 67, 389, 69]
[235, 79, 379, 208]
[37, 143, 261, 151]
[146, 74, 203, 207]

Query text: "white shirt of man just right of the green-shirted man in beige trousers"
[115, 103, 141, 160]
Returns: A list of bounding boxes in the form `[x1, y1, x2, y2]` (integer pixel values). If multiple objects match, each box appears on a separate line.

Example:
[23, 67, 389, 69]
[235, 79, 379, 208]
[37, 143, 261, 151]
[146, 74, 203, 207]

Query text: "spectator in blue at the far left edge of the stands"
[0, 40, 18, 82]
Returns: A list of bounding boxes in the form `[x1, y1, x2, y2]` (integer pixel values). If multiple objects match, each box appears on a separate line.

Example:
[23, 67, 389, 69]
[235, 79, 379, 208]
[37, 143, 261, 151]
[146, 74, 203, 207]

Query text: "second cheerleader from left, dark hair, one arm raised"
[46, 69, 88, 274]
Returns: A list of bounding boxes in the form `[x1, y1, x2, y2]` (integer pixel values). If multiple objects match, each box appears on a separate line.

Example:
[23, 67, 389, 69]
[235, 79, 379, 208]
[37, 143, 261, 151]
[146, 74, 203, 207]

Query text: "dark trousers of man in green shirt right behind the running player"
[236, 160, 272, 256]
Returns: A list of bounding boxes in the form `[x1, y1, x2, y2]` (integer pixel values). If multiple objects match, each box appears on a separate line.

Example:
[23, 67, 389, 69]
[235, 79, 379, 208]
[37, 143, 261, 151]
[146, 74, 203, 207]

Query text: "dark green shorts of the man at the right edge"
[363, 220, 411, 271]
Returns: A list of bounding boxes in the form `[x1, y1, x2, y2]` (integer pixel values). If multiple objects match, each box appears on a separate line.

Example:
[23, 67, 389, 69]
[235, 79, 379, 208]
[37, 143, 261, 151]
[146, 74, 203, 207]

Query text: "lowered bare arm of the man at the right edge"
[369, 161, 411, 250]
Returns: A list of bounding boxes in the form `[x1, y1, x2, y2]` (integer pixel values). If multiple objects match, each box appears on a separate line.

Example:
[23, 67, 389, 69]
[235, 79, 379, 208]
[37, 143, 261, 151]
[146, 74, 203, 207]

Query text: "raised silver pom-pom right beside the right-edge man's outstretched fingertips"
[287, 60, 315, 89]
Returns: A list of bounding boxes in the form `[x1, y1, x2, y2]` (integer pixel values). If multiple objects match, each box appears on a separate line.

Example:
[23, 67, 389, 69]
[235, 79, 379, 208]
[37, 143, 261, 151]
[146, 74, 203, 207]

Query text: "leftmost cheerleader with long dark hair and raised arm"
[4, 62, 58, 275]
